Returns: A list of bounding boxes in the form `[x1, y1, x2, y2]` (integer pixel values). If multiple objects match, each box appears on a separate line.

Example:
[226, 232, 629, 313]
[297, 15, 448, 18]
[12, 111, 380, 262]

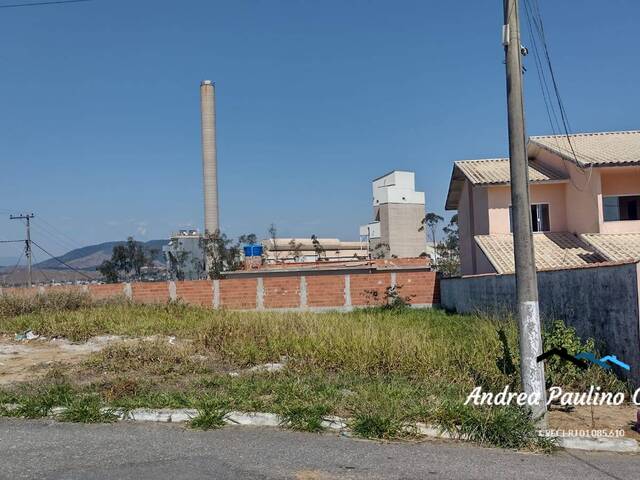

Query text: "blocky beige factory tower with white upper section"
[360, 170, 427, 258]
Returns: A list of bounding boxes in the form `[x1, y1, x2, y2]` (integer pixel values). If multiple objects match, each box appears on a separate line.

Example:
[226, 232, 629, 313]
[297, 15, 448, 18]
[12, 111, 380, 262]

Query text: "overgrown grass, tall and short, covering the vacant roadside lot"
[0, 294, 616, 448]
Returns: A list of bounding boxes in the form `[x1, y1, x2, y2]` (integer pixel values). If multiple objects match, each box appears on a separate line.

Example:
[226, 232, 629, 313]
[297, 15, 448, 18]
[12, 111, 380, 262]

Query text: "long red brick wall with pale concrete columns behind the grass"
[0, 269, 440, 310]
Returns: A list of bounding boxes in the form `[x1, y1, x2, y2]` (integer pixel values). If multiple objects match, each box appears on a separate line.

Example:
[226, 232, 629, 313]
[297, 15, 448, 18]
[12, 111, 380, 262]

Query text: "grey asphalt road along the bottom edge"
[0, 419, 640, 480]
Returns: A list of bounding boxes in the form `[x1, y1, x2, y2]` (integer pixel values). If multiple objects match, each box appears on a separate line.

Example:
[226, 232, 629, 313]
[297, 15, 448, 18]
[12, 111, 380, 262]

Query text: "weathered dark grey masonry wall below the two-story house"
[440, 263, 640, 386]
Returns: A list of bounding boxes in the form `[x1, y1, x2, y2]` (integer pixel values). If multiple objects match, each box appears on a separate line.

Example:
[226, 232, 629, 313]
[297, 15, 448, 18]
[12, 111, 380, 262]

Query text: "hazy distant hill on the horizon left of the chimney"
[35, 240, 169, 270]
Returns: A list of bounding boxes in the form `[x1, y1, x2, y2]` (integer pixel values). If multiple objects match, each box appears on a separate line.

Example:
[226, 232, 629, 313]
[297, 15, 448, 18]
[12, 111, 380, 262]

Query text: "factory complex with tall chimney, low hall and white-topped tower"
[163, 80, 428, 280]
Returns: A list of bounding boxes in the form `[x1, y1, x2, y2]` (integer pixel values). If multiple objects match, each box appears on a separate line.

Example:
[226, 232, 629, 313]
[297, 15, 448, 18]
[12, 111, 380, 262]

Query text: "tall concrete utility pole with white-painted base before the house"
[502, 0, 546, 424]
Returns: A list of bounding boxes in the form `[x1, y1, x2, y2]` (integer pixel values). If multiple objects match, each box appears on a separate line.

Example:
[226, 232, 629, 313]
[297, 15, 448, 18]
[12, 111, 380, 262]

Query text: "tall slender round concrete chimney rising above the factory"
[200, 80, 220, 233]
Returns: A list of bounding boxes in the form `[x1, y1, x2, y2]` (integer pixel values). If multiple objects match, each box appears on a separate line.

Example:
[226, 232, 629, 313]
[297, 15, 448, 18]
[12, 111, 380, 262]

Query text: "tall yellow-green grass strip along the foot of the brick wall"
[0, 292, 517, 394]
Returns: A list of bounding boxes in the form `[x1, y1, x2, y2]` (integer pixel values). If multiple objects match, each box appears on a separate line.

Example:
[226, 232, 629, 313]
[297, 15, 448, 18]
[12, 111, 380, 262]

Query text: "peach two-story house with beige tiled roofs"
[445, 131, 640, 275]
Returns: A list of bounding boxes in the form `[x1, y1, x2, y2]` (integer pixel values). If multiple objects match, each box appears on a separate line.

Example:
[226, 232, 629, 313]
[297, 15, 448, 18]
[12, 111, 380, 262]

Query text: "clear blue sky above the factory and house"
[0, 0, 640, 257]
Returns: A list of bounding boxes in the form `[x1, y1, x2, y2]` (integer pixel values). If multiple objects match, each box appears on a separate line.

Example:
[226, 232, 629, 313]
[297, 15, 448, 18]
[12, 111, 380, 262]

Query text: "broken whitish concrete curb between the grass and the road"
[2, 404, 640, 453]
